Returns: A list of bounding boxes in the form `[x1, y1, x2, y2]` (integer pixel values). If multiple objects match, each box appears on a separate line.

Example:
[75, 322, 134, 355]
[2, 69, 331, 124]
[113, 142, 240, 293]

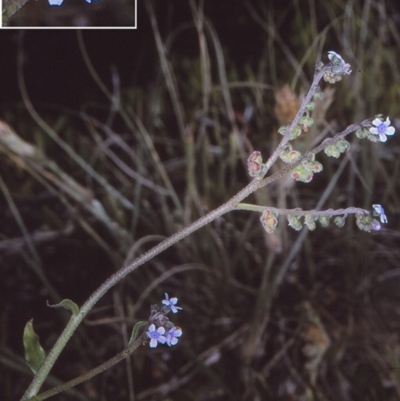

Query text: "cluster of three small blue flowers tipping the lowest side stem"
[147, 294, 182, 348]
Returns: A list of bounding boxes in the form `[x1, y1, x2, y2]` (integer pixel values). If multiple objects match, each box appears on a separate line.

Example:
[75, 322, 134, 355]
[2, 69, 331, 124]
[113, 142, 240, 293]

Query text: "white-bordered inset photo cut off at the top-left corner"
[2, 0, 137, 29]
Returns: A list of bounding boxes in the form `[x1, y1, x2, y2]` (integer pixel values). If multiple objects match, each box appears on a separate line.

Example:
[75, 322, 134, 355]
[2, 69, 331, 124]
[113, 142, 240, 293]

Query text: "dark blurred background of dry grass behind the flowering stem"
[0, 0, 400, 401]
